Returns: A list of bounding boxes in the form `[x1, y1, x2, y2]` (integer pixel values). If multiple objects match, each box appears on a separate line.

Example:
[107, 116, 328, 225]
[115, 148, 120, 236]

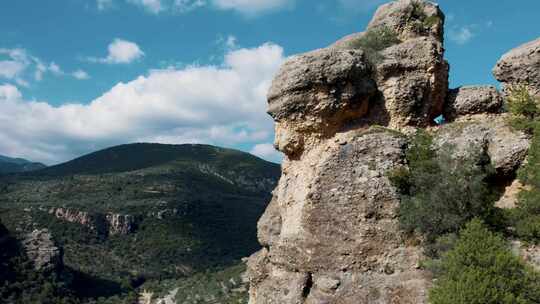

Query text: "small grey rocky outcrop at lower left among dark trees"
[21, 229, 63, 272]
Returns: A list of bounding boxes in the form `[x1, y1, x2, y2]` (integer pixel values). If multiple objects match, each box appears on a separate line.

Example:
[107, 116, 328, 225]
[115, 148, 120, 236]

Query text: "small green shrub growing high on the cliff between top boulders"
[350, 26, 400, 63]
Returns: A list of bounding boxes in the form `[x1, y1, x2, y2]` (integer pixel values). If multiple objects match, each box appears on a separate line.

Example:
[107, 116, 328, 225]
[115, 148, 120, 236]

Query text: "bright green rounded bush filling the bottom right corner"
[429, 220, 540, 304]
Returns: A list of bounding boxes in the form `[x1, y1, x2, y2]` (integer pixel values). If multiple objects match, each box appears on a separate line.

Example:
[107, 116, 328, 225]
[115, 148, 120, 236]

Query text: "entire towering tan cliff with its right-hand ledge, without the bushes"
[248, 0, 535, 304]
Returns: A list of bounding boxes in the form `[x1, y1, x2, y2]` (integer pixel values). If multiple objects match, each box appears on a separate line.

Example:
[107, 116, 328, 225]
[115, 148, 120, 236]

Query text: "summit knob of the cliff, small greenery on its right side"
[368, 0, 445, 42]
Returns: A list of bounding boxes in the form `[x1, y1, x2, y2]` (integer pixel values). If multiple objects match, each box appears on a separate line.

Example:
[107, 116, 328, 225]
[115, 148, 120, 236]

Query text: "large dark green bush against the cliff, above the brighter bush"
[389, 131, 496, 243]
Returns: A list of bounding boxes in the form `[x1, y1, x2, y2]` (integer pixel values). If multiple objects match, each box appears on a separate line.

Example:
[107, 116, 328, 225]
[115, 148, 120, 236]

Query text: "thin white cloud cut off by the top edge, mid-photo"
[212, 0, 296, 15]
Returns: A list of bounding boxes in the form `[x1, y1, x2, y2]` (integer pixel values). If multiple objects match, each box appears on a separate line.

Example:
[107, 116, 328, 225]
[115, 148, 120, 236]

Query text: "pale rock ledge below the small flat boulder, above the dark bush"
[435, 115, 529, 176]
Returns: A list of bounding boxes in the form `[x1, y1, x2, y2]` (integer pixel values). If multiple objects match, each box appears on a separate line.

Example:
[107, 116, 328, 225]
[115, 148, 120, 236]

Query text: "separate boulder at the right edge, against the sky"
[493, 38, 540, 96]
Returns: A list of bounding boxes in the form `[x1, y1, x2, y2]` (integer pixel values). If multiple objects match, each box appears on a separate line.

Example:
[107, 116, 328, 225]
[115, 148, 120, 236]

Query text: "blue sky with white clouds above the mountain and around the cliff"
[0, 0, 540, 164]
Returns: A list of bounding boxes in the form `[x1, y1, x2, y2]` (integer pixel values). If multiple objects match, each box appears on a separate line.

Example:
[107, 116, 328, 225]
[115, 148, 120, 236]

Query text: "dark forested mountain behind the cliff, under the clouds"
[0, 143, 280, 303]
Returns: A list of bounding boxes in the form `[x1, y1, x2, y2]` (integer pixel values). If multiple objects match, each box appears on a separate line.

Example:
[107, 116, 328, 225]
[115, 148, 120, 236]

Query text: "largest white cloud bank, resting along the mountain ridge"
[0, 44, 284, 164]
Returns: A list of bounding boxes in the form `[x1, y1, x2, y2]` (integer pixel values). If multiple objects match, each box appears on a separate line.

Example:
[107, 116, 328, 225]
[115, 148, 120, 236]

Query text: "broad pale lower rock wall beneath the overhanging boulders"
[248, 128, 429, 304]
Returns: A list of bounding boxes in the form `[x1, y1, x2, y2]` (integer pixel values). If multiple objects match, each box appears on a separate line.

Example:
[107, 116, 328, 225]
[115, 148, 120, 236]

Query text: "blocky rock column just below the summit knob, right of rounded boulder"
[370, 37, 449, 128]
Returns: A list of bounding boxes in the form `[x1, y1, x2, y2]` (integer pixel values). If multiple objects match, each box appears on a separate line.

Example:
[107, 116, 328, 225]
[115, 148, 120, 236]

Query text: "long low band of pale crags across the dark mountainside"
[49, 208, 138, 235]
